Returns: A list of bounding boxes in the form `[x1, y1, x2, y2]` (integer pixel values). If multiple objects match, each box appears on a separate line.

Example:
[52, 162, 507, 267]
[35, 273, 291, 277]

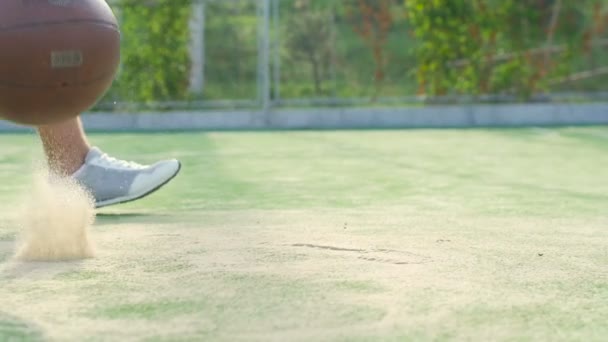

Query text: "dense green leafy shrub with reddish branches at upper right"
[405, 0, 591, 99]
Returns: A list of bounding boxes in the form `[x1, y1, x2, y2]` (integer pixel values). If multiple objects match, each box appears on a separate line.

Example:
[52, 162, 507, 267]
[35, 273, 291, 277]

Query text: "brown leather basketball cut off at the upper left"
[0, 0, 120, 126]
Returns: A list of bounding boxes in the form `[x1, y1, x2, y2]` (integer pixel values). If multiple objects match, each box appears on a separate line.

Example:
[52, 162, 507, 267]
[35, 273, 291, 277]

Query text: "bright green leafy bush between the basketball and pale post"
[105, 0, 191, 102]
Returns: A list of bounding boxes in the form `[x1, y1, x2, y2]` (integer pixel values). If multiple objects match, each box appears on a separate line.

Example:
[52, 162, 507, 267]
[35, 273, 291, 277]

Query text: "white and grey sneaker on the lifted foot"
[72, 147, 181, 208]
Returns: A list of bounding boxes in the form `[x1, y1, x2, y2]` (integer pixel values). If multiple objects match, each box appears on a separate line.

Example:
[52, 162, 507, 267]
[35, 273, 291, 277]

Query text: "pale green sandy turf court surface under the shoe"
[0, 127, 608, 341]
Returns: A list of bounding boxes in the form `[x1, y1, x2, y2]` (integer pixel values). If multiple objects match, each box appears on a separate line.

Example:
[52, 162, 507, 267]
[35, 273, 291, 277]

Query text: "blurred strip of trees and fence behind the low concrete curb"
[96, 0, 608, 111]
